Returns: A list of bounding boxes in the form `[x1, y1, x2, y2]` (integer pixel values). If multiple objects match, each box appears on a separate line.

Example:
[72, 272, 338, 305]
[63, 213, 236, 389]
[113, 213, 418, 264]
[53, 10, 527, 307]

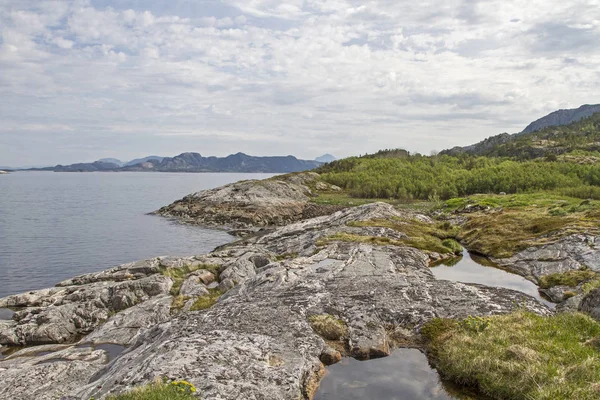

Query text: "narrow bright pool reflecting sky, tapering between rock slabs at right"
[431, 250, 556, 308]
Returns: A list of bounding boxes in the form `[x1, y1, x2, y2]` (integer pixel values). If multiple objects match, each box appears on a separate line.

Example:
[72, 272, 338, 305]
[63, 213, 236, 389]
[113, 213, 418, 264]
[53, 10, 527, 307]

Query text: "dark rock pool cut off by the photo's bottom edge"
[314, 349, 481, 400]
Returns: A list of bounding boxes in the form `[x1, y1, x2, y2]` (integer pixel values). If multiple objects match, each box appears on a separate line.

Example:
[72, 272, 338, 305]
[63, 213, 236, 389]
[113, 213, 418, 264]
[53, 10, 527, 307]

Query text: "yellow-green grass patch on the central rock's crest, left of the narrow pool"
[317, 219, 462, 254]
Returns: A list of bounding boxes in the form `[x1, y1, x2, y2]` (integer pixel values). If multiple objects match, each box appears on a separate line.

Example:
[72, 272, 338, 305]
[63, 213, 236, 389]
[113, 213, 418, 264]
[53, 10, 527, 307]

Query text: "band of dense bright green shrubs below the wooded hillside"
[318, 154, 600, 201]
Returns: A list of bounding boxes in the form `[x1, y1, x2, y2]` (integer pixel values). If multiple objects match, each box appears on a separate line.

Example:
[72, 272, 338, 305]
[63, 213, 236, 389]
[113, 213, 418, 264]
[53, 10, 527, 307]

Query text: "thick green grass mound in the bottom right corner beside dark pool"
[422, 311, 600, 400]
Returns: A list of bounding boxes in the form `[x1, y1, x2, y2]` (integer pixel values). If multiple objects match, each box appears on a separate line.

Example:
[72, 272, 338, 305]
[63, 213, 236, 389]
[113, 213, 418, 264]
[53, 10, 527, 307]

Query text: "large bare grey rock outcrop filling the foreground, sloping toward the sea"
[0, 203, 550, 400]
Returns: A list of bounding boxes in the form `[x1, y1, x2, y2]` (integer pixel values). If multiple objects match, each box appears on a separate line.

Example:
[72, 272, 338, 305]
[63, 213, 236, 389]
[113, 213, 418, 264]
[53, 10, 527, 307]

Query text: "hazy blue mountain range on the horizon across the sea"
[27, 153, 322, 173]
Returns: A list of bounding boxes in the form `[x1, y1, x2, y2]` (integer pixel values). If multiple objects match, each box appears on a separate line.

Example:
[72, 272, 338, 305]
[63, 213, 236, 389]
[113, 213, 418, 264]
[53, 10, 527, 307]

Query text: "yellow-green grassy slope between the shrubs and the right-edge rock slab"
[445, 193, 600, 258]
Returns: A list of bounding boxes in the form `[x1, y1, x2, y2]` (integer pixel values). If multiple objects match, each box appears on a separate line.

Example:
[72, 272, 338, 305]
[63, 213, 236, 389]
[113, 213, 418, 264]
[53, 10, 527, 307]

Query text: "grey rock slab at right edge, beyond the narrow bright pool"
[492, 234, 600, 283]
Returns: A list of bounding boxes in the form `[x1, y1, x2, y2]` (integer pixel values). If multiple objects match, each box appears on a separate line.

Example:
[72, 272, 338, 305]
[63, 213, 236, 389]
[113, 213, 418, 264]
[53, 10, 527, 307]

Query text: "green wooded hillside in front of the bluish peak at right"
[441, 112, 600, 162]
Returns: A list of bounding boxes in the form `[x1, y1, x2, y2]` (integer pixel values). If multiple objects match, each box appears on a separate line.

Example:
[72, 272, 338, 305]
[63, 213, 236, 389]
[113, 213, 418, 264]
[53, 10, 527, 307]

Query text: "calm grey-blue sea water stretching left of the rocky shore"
[0, 172, 273, 297]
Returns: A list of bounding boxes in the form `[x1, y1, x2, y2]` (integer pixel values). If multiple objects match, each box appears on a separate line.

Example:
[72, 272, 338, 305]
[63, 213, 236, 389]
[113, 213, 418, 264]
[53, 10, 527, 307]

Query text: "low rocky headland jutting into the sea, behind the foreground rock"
[155, 172, 341, 229]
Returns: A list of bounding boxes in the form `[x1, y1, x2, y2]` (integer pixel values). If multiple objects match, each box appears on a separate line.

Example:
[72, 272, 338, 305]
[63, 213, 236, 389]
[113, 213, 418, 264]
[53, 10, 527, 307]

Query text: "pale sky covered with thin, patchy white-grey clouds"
[0, 0, 600, 166]
